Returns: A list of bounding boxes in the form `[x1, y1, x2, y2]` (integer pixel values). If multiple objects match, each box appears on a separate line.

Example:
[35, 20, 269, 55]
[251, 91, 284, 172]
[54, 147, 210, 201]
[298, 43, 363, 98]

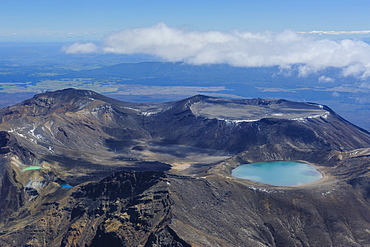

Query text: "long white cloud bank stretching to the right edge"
[64, 23, 370, 78]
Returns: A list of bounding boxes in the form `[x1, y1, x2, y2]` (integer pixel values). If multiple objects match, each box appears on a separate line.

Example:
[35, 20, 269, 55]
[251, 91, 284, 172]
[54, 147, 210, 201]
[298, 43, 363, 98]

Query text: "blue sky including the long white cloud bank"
[0, 0, 370, 79]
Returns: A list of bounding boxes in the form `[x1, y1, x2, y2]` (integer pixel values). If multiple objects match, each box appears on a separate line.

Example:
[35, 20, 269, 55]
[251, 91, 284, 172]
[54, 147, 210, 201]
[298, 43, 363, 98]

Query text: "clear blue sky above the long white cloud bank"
[0, 0, 370, 42]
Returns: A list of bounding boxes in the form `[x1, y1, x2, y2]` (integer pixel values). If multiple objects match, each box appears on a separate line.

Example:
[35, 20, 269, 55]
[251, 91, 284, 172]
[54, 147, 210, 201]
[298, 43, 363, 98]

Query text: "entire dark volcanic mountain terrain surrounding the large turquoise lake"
[0, 89, 370, 246]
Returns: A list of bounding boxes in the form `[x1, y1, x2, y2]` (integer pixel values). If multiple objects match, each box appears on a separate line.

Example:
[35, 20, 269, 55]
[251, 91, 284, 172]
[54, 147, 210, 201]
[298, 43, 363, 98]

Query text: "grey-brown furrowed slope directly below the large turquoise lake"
[170, 166, 370, 246]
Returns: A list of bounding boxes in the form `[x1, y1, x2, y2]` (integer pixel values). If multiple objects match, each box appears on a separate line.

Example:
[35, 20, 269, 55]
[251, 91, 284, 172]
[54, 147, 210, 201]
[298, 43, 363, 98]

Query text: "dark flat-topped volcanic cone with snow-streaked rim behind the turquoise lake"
[147, 96, 370, 153]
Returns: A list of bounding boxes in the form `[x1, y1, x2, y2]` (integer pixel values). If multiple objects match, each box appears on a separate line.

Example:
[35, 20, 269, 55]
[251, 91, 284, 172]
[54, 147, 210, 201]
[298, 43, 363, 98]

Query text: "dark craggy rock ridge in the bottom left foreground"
[0, 172, 188, 246]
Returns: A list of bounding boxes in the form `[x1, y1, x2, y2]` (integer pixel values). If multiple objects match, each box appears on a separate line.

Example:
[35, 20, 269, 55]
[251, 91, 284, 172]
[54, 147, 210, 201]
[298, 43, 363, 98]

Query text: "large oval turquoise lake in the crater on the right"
[231, 161, 322, 186]
